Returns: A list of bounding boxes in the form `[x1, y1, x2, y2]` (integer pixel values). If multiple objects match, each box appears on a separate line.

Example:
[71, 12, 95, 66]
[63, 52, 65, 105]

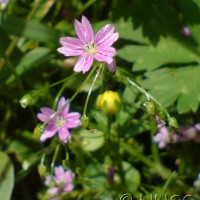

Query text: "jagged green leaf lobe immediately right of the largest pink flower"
[118, 37, 200, 71]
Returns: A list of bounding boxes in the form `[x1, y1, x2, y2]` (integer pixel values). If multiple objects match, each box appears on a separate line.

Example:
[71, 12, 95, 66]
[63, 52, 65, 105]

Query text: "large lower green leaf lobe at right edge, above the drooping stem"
[142, 66, 200, 113]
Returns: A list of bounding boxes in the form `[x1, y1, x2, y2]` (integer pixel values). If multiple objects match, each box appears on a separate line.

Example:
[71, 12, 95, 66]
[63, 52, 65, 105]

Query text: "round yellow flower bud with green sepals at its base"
[97, 91, 121, 115]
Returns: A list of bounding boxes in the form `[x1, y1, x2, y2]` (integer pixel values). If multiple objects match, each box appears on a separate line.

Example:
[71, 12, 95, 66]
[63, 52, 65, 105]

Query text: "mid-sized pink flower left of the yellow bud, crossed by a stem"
[37, 97, 81, 143]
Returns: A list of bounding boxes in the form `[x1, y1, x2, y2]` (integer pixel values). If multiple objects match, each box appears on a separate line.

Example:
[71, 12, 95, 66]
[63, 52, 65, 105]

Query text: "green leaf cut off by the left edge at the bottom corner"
[0, 151, 14, 200]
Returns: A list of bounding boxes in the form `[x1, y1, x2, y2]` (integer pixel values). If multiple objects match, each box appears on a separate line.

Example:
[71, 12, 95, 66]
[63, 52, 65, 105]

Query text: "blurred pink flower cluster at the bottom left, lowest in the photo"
[45, 166, 75, 196]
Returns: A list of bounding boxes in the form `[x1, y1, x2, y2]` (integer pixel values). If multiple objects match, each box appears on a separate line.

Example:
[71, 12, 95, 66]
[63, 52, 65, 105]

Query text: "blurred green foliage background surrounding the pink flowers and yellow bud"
[0, 0, 200, 199]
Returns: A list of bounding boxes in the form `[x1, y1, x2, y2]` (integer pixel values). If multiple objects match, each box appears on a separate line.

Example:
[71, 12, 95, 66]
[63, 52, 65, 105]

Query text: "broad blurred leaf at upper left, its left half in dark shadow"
[2, 16, 59, 42]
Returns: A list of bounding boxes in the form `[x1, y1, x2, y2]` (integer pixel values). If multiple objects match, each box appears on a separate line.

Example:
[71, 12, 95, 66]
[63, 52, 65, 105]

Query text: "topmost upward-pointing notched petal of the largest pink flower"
[74, 16, 94, 44]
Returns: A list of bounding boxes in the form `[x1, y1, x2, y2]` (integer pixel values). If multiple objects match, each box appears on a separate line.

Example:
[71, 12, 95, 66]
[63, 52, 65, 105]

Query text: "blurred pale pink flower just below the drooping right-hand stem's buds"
[153, 126, 178, 148]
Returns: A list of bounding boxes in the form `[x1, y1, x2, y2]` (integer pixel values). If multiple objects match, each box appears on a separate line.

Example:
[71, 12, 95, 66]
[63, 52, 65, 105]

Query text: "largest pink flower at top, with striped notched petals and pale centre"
[58, 16, 119, 73]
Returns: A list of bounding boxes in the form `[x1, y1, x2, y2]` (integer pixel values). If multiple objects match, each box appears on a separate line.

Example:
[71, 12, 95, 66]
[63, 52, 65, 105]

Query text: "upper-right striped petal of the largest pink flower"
[95, 24, 119, 46]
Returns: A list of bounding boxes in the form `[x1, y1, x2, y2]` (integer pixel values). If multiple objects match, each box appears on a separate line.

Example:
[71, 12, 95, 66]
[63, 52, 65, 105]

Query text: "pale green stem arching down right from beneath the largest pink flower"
[116, 70, 170, 119]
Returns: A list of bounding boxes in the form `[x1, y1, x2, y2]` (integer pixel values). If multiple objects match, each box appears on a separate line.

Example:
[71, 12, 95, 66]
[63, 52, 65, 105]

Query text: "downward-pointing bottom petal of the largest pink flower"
[74, 54, 93, 73]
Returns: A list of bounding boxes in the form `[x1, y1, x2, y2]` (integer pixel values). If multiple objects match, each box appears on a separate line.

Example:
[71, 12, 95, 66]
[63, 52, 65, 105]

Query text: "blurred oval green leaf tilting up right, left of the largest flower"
[7, 47, 52, 84]
